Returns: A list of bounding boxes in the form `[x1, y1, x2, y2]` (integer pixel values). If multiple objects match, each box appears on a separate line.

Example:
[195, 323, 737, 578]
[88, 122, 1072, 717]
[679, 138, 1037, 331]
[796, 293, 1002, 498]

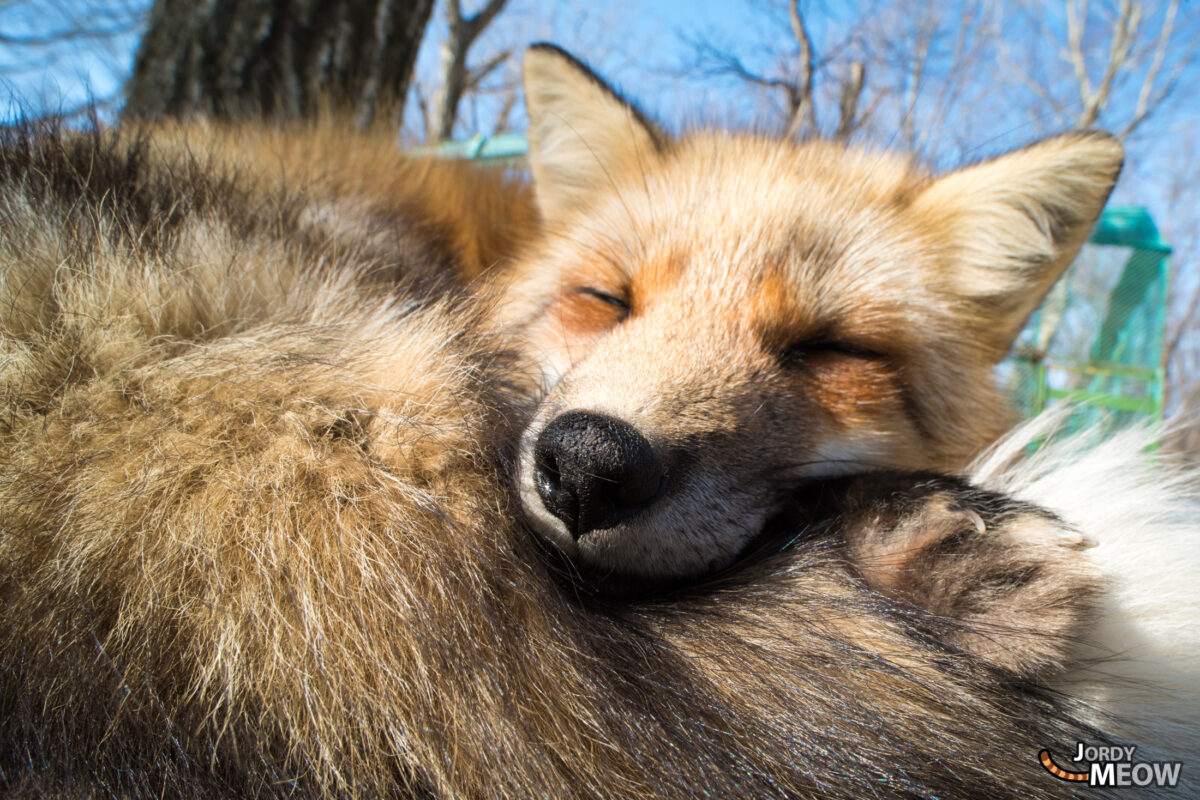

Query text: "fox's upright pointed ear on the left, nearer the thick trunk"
[524, 44, 662, 221]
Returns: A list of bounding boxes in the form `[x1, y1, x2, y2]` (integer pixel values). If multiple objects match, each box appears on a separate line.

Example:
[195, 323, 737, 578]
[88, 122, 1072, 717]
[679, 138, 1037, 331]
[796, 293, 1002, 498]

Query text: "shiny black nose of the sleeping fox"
[533, 411, 666, 539]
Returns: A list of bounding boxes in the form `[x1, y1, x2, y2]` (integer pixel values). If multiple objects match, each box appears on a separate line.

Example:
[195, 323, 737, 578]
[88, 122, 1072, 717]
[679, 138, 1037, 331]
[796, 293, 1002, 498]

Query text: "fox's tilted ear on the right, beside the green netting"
[914, 131, 1124, 361]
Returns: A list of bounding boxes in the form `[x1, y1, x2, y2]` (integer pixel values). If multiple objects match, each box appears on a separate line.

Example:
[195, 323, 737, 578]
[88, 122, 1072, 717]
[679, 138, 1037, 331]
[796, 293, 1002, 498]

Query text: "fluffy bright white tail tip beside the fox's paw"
[971, 411, 1200, 777]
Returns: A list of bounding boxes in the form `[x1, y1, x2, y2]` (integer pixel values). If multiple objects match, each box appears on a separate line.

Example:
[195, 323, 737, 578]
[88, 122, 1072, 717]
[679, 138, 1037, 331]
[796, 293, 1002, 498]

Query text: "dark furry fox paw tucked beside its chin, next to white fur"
[820, 474, 1103, 676]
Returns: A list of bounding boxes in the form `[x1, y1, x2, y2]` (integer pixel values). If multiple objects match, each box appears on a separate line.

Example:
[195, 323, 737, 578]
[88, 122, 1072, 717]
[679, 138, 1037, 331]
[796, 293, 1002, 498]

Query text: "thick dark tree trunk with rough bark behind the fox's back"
[125, 0, 433, 127]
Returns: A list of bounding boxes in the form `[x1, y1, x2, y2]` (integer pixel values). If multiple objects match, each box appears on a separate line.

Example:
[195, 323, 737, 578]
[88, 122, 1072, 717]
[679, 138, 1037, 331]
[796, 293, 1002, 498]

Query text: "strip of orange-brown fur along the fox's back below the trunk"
[145, 116, 538, 282]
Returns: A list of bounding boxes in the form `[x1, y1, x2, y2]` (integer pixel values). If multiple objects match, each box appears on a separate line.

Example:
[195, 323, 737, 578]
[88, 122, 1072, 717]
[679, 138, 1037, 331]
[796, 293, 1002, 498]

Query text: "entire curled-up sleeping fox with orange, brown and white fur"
[0, 48, 1200, 800]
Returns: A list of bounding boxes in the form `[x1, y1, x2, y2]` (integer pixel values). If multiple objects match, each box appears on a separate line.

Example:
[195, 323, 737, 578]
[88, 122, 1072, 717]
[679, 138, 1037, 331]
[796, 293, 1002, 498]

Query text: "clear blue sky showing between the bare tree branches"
[7, 0, 1200, 148]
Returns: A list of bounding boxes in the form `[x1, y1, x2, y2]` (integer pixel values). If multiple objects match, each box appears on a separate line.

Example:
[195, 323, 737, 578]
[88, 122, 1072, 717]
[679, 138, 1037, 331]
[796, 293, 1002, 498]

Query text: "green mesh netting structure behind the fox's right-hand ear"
[1001, 206, 1171, 429]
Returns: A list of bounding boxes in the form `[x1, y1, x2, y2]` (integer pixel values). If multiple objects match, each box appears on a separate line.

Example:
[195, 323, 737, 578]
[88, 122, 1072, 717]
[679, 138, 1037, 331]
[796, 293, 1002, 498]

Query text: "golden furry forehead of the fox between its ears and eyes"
[542, 134, 936, 335]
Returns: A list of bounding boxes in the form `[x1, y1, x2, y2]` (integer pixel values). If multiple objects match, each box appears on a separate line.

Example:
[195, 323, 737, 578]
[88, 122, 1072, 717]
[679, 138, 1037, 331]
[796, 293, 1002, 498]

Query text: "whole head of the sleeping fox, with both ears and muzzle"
[504, 46, 1122, 578]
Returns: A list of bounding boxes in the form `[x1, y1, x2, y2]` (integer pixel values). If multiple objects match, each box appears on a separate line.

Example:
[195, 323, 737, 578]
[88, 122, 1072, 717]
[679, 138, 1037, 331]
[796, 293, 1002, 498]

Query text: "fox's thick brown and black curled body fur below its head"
[0, 120, 1132, 799]
